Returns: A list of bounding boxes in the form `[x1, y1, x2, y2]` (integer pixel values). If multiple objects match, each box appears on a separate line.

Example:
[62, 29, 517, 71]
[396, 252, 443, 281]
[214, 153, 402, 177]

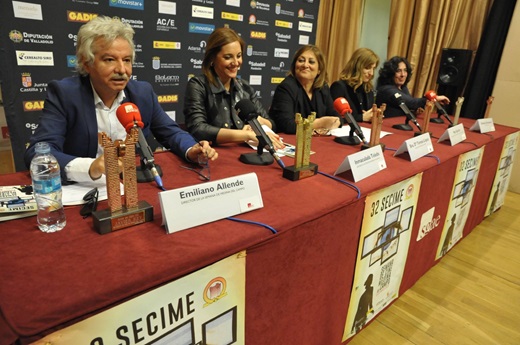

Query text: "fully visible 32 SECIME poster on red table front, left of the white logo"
[342, 173, 422, 341]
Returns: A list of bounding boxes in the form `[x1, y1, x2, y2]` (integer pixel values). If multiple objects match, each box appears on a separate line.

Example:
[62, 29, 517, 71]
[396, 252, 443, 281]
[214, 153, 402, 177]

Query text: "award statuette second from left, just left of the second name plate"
[283, 113, 318, 181]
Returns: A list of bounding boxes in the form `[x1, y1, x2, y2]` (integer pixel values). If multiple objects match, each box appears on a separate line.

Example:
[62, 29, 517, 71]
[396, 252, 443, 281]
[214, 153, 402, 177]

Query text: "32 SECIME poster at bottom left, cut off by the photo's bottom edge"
[34, 251, 246, 345]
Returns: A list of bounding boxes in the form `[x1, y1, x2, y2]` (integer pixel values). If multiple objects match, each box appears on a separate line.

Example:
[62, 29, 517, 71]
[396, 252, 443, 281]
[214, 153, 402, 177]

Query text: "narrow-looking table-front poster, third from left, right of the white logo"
[435, 147, 484, 260]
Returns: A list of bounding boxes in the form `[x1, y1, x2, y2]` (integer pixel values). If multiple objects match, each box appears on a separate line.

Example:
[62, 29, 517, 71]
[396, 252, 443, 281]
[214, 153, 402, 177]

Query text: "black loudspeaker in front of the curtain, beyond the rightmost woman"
[437, 48, 473, 86]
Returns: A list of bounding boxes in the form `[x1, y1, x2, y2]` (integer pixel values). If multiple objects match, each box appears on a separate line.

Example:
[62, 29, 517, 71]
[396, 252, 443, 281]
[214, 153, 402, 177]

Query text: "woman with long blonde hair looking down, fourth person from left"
[330, 48, 379, 122]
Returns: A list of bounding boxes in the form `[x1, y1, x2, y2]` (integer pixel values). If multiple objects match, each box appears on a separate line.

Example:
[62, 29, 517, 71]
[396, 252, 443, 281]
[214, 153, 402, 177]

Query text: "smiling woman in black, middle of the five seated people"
[269, 45, 341, 134]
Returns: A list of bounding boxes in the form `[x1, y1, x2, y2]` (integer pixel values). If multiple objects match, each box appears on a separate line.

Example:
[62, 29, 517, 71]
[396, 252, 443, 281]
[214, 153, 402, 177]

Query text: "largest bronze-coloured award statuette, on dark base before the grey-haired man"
[92, 128, 153, 234]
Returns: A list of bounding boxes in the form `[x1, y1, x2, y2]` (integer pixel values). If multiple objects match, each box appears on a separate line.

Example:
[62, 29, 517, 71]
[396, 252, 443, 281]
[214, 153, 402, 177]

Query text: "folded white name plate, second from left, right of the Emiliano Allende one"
[334, 145, 386, 182]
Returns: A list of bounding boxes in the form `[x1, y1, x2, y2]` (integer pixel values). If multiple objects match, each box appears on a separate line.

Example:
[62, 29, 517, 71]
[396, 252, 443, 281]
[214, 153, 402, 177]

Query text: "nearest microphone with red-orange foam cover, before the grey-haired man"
[116, 102, 164, 190]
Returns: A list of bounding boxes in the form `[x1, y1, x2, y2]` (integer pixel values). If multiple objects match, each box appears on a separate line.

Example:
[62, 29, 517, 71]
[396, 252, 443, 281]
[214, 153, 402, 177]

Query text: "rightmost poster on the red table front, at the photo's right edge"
[485, 132, 519, 217]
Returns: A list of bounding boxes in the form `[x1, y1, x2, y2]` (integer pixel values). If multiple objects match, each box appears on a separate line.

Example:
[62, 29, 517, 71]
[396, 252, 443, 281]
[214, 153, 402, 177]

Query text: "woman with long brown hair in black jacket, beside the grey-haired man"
[184, 27, 283, 148]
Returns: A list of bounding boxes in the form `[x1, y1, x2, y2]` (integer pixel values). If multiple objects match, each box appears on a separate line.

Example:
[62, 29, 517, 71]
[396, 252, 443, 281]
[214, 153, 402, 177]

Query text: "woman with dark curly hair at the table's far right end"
[376, 56, 450, 117]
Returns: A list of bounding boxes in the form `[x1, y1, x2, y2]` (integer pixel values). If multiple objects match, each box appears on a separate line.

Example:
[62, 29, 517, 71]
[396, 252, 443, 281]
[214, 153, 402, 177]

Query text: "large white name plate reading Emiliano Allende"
[159, 173, 264, 234]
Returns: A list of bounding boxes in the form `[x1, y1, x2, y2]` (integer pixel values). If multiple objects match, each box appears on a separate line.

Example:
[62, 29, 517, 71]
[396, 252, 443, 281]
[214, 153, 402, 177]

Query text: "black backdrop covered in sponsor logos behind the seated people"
[0, 0, 319, 171]
